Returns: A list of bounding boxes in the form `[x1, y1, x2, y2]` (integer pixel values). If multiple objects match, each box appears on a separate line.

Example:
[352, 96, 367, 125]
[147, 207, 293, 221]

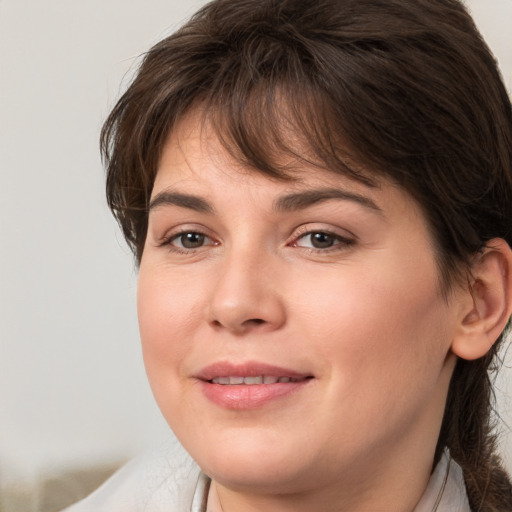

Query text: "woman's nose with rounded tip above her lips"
[207, 249, 286, 335]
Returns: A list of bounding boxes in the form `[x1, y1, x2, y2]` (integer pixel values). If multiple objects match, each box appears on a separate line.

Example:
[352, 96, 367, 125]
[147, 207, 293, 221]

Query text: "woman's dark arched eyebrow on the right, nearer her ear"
[275, 188, 383, 214]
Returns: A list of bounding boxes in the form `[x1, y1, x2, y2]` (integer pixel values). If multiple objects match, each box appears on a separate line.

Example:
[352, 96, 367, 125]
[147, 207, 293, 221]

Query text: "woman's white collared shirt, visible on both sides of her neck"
[63, 446, 471, 512]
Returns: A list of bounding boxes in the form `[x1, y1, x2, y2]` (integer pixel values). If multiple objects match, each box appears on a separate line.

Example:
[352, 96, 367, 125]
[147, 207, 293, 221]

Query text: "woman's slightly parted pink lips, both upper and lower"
[196, 362, 313, 410]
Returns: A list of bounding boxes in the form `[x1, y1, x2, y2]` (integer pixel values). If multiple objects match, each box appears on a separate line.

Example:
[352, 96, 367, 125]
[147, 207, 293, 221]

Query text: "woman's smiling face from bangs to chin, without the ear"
[138, 116, 460, 498]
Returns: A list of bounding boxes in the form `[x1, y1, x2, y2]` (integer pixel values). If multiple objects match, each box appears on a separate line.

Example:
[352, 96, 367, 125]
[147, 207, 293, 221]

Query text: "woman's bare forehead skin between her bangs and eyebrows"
[153, 109, 380, 195]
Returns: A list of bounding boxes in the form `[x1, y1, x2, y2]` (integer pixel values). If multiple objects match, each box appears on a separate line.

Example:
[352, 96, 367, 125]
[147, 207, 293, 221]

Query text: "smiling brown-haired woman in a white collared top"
[66, 0, 512, 512]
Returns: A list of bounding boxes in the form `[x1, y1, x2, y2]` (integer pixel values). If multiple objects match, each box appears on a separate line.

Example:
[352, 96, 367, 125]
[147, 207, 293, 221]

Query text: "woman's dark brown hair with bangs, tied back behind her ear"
[101, 0, 512, 511]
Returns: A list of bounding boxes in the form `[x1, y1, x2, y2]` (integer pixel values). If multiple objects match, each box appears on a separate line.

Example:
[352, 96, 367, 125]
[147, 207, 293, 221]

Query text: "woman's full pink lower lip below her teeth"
[202, 379, 311, 410]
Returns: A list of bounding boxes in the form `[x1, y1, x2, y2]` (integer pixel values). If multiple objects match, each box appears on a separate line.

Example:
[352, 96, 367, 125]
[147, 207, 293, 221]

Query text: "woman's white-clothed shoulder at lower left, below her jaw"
[64, 443, 201, 512]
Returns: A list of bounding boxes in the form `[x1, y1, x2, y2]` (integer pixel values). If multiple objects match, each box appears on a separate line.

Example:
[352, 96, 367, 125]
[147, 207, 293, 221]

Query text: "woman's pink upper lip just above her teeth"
[195, 361, 312, 381]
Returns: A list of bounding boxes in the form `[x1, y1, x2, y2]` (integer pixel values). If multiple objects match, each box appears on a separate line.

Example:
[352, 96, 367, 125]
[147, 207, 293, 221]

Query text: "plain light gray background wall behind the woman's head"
[0, 0, 512, 492]
